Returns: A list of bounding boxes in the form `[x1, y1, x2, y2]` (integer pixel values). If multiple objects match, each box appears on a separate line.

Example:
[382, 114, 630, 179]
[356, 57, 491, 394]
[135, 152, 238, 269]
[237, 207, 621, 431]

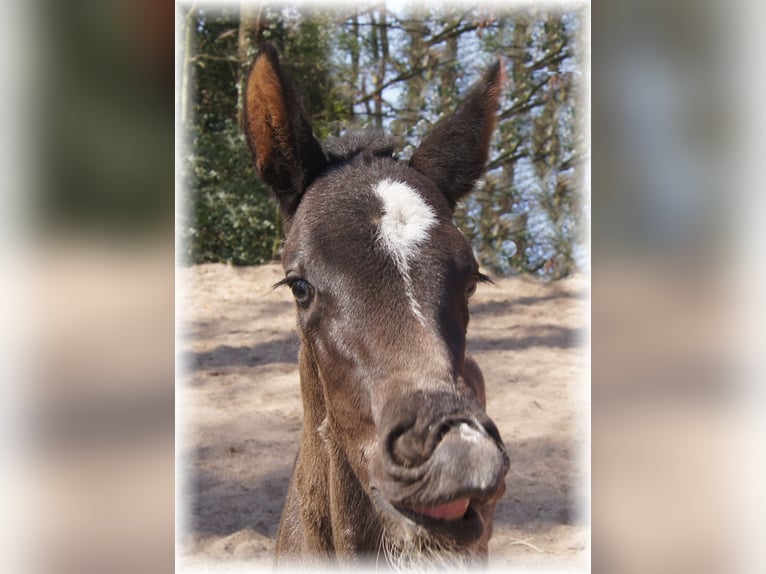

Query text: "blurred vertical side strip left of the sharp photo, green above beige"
[0, 0, 175, 573]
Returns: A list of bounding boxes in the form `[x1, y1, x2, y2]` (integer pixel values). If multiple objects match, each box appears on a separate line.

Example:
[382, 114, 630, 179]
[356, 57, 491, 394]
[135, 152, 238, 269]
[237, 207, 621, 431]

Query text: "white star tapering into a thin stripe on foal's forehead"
[374, 179, 436, 324]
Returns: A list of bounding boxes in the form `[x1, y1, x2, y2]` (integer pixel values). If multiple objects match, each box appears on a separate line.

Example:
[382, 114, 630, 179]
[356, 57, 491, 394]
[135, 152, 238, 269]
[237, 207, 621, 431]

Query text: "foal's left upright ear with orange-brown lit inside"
[245, 42, 327, 222]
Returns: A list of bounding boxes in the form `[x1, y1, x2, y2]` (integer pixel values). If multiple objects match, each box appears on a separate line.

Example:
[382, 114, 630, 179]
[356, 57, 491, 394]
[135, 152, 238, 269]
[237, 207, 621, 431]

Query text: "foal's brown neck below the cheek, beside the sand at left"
[295, 349, 379, 558]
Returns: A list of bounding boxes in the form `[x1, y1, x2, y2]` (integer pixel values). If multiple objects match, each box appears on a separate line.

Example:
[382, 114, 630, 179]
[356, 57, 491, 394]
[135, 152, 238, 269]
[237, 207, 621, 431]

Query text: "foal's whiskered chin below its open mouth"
[370, 487, 486, 571]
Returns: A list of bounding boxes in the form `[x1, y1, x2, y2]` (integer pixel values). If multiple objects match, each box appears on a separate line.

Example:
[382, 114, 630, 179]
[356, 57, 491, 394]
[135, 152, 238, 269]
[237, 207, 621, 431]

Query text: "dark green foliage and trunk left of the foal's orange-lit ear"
[181, 12, 280, 265]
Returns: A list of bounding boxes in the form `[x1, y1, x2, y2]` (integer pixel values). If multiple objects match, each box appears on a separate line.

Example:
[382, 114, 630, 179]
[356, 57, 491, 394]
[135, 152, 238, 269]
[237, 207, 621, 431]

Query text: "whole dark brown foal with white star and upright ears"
[246, 44, 508, 566]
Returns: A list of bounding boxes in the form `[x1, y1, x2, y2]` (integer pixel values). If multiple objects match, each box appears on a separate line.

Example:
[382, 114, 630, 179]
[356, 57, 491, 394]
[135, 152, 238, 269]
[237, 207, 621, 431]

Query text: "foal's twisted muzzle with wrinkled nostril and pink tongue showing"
[372, 395, 509, 543]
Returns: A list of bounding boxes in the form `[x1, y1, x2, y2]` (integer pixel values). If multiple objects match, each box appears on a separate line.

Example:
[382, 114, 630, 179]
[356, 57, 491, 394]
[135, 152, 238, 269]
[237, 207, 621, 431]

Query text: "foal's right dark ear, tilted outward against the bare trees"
[410, 60, 505, 209]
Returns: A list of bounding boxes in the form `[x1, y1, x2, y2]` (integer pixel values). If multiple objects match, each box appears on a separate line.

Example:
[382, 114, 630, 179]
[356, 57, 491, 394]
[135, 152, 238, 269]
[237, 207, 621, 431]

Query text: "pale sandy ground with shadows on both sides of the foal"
[177, 265, 589, 569]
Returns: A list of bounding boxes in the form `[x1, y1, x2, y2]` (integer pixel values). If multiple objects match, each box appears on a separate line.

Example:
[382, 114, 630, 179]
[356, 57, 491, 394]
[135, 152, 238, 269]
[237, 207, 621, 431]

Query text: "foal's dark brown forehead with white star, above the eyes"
[287, 163, 464, 279]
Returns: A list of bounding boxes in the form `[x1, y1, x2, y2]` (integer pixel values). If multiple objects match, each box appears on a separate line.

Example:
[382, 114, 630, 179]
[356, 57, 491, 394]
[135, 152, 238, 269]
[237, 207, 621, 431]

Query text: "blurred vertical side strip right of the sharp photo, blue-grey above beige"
[591, 0, 766, 572]
